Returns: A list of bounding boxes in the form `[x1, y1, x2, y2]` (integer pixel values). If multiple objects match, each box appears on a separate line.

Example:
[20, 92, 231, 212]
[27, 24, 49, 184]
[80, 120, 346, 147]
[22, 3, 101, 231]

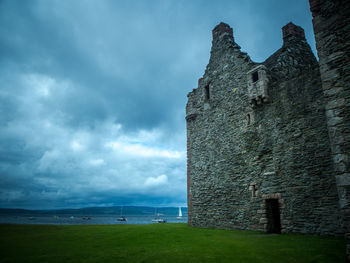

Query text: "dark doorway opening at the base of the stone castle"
[266, 199, 281, 234]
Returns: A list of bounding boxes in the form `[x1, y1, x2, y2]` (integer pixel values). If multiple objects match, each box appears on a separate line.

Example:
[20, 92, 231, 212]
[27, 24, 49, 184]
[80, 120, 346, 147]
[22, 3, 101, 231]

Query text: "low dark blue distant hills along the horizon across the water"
[0, 206, 187, 216]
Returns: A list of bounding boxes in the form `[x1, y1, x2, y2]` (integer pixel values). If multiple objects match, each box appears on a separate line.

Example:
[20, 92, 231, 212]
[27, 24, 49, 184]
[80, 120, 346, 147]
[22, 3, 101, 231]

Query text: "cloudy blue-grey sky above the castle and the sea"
[0, 0, 315, 209]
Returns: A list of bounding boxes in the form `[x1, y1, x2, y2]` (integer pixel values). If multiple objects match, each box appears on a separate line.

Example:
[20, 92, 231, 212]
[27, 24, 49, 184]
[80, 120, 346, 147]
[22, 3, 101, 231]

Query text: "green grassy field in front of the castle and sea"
[0, 224, 345, 263]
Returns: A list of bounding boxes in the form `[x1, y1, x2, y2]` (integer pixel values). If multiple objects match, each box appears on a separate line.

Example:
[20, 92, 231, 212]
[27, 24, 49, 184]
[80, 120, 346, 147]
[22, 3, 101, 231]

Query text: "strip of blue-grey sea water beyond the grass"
[0, 215, 187, 225]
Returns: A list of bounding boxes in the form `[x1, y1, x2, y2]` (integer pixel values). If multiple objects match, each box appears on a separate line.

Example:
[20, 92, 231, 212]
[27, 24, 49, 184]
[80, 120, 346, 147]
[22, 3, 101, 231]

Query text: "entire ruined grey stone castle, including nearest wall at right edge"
[186, 0, 350, 256]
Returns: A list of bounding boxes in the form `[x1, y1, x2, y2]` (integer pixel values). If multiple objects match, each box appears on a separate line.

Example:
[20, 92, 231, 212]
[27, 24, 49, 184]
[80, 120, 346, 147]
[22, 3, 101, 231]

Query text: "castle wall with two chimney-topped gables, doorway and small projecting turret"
[186, 23, 342, 235]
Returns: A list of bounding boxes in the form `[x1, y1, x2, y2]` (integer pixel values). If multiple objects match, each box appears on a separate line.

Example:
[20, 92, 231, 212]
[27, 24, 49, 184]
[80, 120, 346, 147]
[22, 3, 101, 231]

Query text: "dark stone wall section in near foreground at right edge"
[309, 0, 350, 262]
